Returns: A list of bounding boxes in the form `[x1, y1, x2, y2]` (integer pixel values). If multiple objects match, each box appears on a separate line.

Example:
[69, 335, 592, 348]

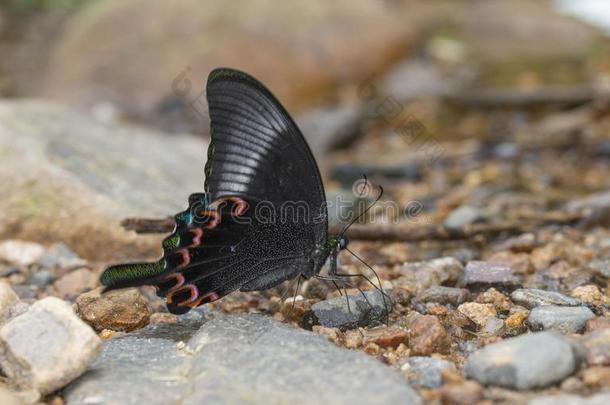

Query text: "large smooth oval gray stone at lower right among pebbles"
[464, 332, 577, 390]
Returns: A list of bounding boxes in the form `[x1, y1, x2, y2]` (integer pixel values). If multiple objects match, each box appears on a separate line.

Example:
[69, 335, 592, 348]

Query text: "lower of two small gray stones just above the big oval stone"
[527, 305, 595, 334]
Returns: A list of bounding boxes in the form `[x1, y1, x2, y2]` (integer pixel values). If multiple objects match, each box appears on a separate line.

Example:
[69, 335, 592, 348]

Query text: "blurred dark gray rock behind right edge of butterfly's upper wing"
[297, 104, 364, 156]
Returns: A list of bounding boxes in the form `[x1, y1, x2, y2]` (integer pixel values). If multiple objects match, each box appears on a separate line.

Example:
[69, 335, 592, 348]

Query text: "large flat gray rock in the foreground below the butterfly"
[65, 315, 421, 405]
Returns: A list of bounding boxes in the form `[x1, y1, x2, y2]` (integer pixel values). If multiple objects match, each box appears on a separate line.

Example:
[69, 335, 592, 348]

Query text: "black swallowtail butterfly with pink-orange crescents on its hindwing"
[101, 68, 391, 314]
